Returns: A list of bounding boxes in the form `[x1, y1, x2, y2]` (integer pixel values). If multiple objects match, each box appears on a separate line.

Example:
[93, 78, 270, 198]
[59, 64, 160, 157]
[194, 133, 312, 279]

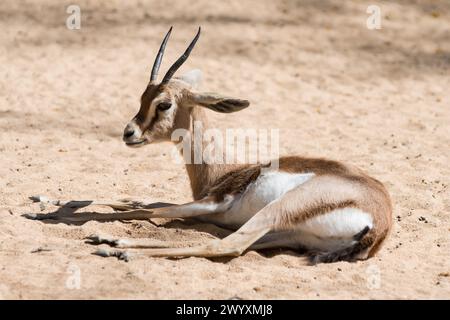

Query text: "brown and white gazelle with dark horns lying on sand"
[36, 28, 392, 263]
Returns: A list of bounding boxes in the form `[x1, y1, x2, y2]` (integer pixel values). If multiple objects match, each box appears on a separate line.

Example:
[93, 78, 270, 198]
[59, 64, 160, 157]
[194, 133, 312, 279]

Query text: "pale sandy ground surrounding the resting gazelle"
[0, 0, 450, 299]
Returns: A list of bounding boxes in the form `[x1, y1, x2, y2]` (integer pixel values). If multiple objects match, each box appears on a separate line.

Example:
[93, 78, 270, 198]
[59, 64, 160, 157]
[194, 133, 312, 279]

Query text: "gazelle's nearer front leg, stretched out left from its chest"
[33, 196, 234, 222]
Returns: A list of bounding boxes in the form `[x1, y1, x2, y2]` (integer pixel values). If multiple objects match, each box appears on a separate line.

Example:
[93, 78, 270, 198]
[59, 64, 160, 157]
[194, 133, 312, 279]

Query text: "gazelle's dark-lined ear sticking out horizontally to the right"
[186, 93, 250, 113]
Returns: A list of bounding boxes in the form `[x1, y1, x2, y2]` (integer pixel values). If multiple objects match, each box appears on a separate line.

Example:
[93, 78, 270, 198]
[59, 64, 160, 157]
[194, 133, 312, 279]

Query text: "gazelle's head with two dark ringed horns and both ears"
[123, 27, 249, 147]
